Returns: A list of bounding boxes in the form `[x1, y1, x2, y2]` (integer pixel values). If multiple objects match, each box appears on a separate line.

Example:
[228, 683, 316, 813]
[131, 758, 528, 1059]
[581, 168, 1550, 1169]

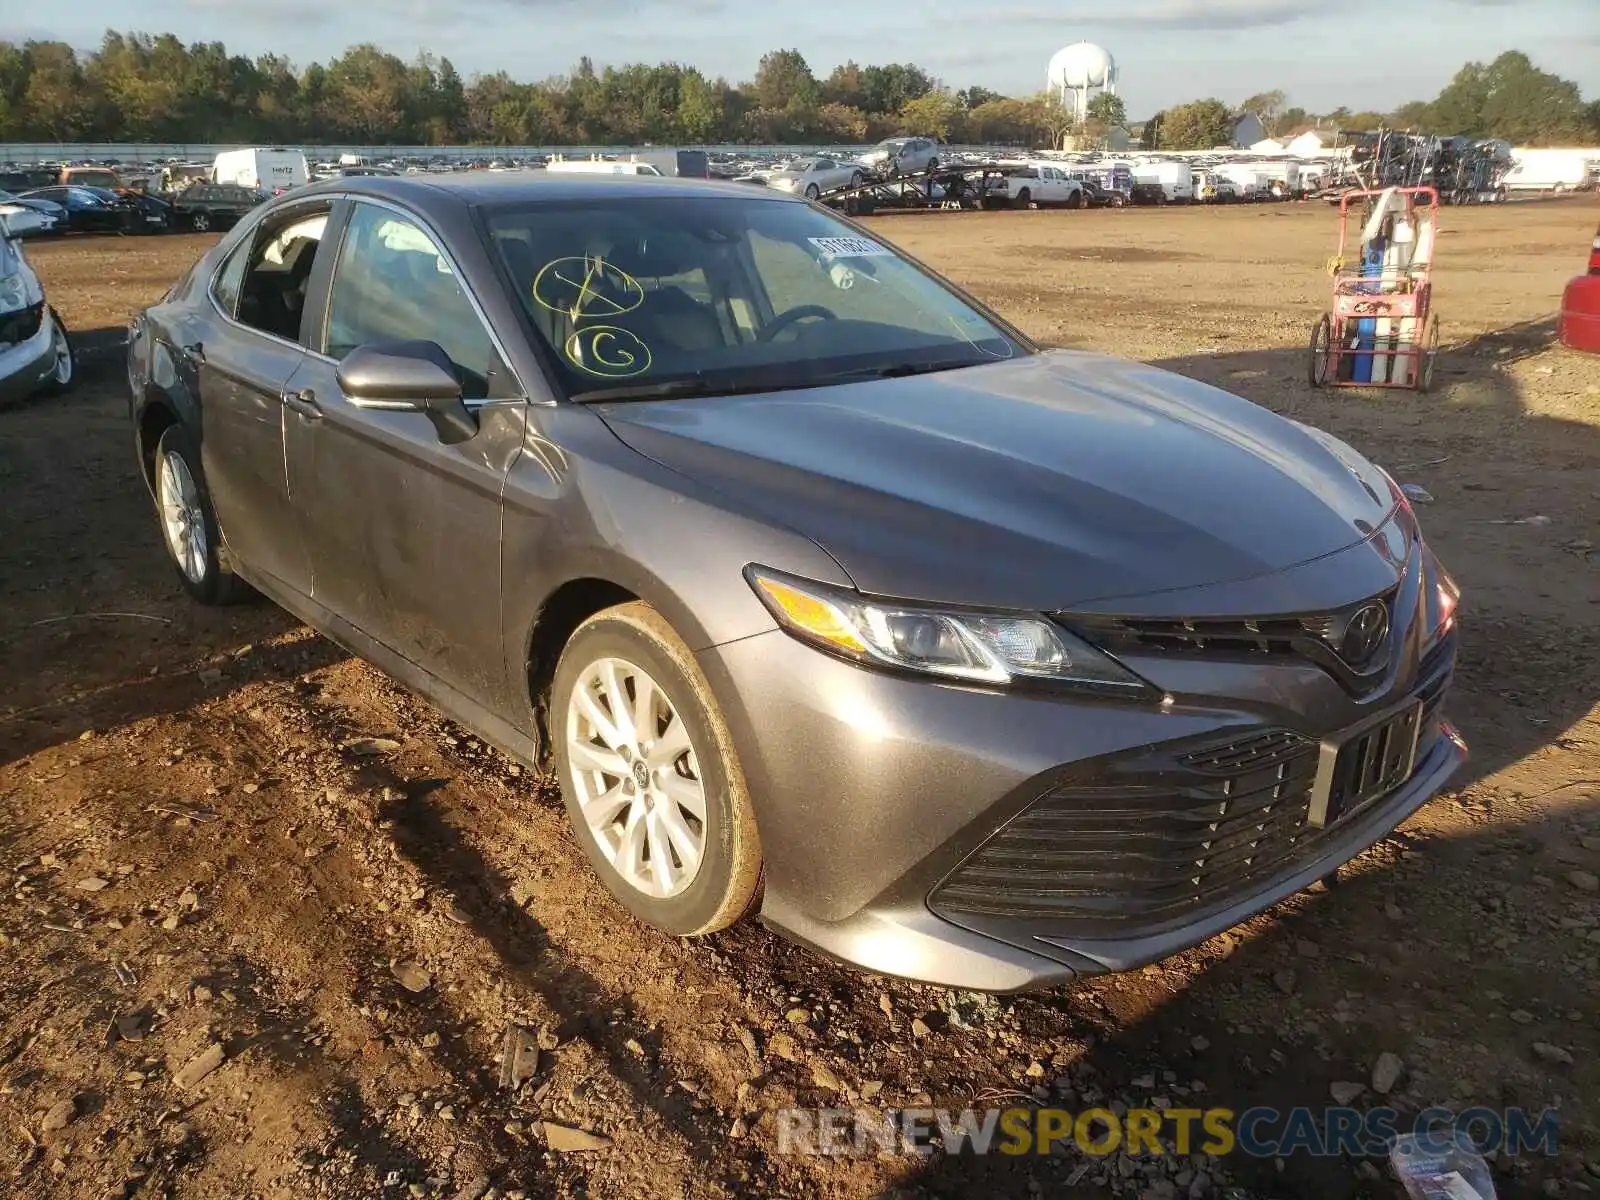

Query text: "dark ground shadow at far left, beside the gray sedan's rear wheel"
[0, 342, 346, 762]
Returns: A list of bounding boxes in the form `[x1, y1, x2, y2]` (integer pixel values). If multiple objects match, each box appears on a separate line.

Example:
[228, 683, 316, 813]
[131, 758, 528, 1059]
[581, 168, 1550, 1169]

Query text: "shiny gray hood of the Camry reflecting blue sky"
[598, 352, 1395, 610]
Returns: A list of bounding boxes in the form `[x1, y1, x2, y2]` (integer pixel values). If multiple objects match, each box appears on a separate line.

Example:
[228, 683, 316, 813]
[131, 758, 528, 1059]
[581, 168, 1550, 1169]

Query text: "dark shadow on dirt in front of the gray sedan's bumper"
[880, 800, 1600, 1200]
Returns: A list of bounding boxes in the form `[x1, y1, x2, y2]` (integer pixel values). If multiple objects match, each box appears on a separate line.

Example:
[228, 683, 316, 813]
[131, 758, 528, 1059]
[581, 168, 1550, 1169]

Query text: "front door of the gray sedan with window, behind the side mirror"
[286, 200, 526, 707]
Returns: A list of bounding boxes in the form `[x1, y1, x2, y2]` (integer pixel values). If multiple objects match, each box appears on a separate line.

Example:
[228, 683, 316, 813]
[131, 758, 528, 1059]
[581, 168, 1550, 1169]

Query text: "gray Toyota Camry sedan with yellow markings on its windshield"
[128, 173, 1466, 990]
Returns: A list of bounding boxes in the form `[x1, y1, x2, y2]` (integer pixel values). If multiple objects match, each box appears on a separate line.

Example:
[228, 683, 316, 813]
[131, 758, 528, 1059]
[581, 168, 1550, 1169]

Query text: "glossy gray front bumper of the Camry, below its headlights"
[701, 582, 1466, 992]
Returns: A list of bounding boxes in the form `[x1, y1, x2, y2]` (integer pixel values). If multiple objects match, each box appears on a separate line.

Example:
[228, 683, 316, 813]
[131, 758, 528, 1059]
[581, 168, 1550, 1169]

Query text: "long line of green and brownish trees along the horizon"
[0, 30, 1600, 149]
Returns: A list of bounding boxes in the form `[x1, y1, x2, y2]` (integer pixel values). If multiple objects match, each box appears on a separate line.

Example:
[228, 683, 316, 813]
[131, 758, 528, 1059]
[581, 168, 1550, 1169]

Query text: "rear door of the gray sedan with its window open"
[198, 202, 339, 594]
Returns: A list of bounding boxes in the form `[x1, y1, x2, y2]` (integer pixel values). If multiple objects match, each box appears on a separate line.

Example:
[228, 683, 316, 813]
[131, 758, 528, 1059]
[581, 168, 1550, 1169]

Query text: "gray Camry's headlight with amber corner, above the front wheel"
[747, 566, 1154, 696]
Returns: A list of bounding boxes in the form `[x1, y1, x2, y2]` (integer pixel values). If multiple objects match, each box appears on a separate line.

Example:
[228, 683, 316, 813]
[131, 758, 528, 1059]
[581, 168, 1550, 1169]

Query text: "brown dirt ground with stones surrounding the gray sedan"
[0, 198, 1600, 1200]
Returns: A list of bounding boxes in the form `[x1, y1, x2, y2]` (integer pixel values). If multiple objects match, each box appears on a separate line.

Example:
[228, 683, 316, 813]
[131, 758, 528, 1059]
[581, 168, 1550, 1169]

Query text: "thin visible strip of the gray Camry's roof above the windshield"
[283, 170, 805, 211]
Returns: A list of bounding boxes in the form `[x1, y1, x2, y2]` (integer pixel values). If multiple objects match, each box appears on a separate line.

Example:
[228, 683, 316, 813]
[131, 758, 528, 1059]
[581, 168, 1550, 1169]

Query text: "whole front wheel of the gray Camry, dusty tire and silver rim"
[549, 603, 762, 938]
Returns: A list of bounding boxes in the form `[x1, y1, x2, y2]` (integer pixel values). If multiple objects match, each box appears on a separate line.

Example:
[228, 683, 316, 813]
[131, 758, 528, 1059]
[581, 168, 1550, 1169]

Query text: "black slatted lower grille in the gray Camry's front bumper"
[928, 637, 1454, 939]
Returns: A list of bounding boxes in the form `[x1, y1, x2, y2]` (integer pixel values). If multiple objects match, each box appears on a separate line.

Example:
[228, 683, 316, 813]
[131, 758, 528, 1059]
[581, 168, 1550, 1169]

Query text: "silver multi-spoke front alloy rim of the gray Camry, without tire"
[566, 658, 706, 899]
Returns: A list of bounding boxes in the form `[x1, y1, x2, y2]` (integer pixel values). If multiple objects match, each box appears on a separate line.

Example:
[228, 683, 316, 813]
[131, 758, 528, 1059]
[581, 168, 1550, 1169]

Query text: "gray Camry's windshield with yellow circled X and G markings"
[486, 195, 1029, 395]
